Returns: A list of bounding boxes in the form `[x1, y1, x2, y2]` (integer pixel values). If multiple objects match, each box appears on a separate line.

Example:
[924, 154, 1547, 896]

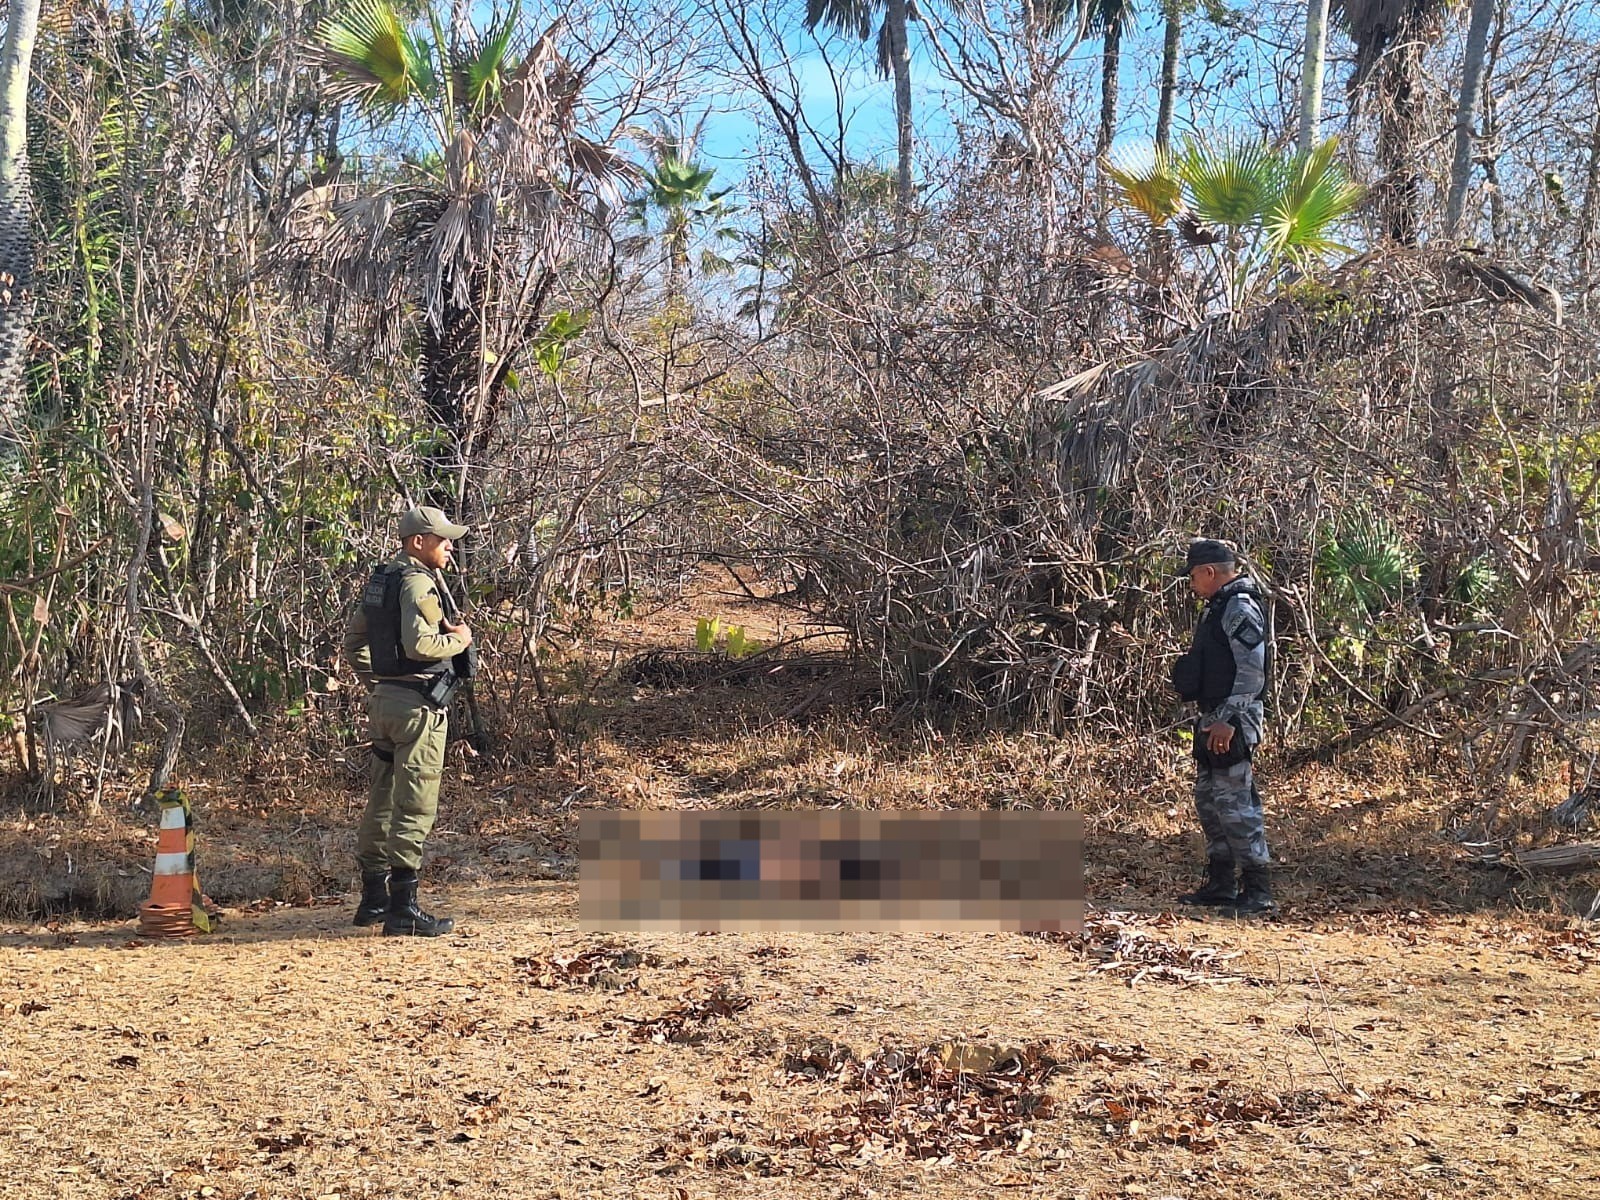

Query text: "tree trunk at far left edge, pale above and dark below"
[0, 0, 38, 453]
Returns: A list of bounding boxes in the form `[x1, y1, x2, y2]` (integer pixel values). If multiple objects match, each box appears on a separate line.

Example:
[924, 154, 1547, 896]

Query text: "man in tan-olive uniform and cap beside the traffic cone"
[344, 507, 472, 938]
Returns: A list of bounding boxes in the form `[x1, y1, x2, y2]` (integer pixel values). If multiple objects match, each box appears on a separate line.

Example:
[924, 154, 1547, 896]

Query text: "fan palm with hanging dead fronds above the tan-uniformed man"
[290, 0, 629, 506]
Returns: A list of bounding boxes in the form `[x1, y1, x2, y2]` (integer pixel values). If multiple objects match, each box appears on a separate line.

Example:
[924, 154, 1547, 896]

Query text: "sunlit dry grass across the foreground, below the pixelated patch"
[0, 882, 1600, 1200]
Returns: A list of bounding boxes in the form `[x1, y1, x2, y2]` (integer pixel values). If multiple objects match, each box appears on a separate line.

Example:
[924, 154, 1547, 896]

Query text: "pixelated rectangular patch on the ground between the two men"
[579, 810, 1083, 933]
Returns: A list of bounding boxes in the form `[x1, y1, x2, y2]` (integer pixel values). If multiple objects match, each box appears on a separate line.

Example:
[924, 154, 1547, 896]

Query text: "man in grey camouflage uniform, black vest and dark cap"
[1173, 539, 1274, 914]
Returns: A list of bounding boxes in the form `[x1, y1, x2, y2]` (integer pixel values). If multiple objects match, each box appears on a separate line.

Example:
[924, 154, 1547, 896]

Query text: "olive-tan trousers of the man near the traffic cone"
[355, 683, 450, 874]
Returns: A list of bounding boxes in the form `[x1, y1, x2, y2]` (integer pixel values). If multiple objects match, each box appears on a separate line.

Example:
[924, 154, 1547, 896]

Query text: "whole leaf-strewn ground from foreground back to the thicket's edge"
[0, 569, 1600, 1200]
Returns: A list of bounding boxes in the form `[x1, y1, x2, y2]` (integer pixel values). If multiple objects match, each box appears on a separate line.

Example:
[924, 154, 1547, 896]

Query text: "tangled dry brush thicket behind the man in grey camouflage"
[668, 200, 1600, 819]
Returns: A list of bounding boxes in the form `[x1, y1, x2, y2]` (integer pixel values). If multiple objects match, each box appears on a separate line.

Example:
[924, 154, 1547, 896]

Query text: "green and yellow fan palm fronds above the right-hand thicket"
[1104, 138, 1362, 315]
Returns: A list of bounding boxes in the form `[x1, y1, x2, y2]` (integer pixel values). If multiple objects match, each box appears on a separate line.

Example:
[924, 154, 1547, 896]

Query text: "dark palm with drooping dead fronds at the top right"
[1330, 0, 1451, 245]
